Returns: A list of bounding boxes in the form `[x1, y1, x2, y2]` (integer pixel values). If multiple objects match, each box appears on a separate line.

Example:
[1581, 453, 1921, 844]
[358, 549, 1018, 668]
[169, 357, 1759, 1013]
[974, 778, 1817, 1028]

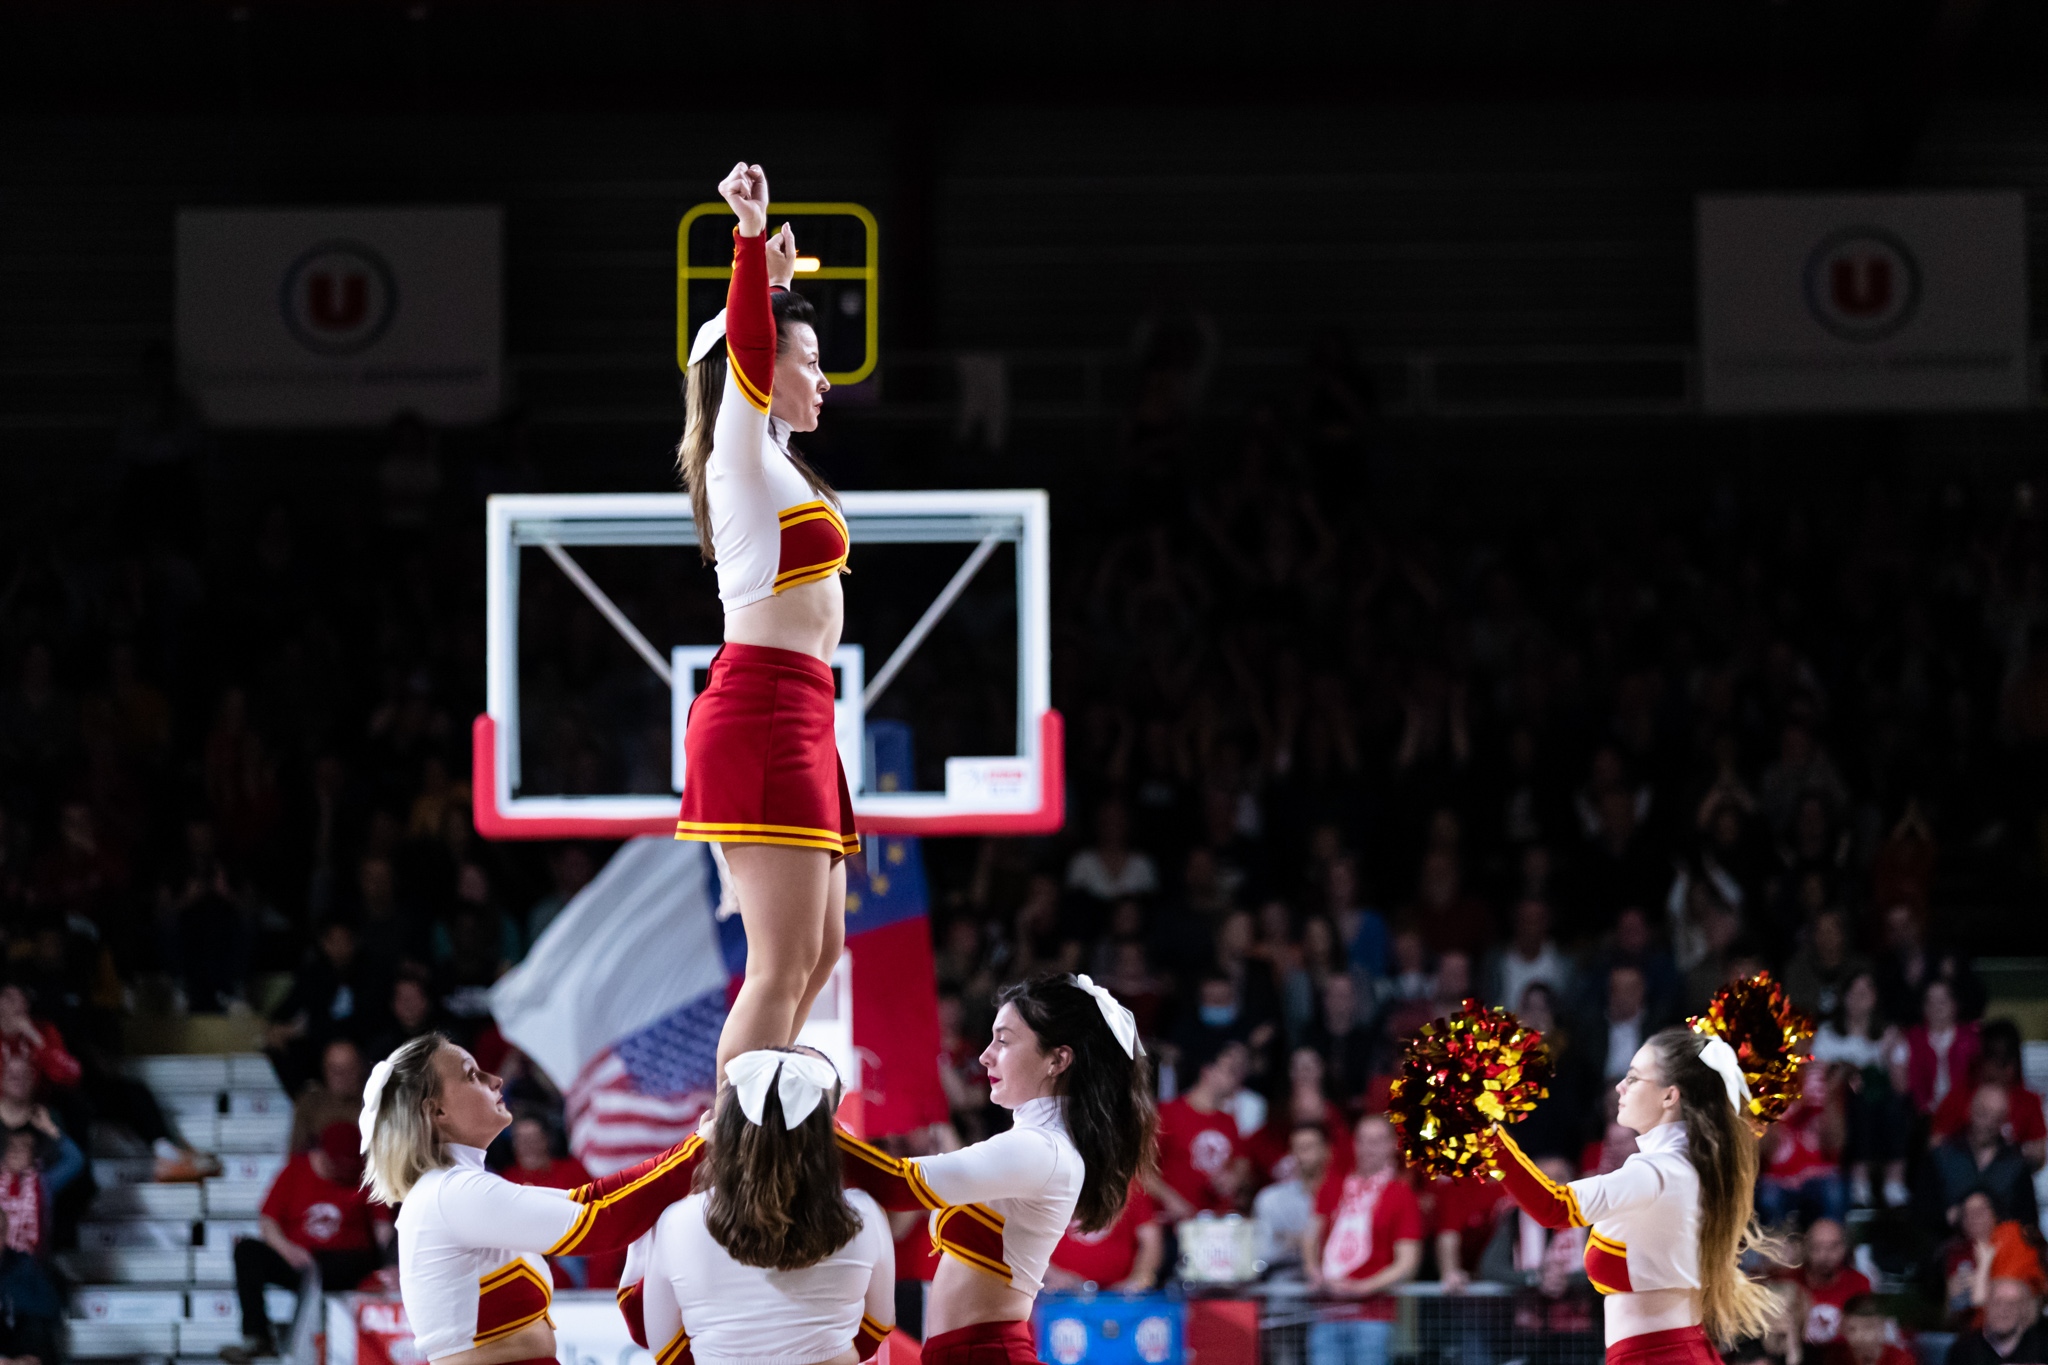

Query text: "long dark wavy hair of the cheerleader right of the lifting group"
[995, 972, 1159, 1232]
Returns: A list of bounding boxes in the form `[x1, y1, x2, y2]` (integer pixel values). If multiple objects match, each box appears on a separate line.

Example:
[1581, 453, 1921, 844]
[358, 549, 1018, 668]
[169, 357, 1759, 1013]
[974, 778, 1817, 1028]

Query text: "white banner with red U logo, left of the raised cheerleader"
[176, 207, 504, 426]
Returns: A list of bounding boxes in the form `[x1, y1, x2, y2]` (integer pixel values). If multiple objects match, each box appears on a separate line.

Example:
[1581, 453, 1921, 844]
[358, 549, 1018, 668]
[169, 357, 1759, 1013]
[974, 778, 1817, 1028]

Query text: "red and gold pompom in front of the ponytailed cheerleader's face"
[1386, 1001, 1550, 1175]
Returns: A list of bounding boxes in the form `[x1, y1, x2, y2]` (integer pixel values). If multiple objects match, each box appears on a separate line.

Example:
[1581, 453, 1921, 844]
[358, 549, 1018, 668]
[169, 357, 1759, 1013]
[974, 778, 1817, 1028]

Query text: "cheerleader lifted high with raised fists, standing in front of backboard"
[676, 162, 860, 1076]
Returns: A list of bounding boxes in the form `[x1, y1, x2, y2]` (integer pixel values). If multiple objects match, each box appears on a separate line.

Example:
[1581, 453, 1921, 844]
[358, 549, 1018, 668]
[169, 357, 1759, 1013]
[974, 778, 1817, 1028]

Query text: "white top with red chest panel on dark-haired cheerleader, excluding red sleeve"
[905, 1097, 1085, 1295]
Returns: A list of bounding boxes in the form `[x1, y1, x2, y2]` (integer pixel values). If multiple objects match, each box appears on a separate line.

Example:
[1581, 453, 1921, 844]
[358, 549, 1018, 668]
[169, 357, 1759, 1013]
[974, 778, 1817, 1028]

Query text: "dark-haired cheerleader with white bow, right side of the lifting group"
[840, 976, 1157, 1365]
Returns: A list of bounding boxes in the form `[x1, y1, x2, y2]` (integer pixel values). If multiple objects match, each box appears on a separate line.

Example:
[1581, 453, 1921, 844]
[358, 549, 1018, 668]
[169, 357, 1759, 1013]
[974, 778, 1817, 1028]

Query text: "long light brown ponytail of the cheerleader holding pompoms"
[1651, 1027, 1778, 1345]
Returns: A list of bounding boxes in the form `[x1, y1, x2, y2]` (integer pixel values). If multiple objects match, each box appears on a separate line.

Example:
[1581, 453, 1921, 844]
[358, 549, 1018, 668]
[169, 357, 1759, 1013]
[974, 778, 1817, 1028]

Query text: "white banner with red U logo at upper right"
[1700, 192, 2030, 411]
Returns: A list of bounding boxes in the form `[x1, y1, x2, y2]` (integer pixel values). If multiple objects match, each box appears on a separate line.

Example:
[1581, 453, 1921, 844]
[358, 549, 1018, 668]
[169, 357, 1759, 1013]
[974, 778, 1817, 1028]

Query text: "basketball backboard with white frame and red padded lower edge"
[471, 489, 1065, 839]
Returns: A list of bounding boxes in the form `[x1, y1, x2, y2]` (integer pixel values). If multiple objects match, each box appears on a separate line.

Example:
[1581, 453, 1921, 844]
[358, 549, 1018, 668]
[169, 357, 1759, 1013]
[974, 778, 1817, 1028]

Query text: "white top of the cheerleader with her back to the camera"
[643, 1189, 895, 1365]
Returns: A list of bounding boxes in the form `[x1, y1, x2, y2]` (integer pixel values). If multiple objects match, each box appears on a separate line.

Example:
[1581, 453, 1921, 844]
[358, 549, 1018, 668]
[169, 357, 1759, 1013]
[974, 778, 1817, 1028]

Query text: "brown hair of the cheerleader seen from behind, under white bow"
[696, 1048, 860, 1271]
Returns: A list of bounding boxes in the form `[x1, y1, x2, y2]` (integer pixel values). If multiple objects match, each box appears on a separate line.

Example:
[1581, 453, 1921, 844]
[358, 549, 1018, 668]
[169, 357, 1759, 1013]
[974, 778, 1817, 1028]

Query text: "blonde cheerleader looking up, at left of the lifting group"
[360, 1033, 702, 1365]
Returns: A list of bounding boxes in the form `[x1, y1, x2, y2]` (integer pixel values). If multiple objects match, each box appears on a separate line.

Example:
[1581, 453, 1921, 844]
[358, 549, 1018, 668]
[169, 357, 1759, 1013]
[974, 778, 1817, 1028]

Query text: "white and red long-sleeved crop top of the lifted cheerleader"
[705, 233, 848, 612]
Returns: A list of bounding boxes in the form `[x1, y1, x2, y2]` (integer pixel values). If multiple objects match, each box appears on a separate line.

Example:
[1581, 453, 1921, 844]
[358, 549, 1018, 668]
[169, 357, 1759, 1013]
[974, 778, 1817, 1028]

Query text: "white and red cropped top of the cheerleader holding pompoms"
[1493, 1124, 1700, 1293]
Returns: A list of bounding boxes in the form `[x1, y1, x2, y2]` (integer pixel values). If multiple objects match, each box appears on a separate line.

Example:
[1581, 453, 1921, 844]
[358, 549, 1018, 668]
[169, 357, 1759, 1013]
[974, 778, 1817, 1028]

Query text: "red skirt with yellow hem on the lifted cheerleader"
[676, 645, 860, 860]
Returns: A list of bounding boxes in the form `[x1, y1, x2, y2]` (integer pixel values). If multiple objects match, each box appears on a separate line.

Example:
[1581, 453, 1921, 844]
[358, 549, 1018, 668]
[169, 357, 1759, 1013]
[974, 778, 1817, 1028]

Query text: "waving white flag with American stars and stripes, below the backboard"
[492, 837, 745, 1175]
